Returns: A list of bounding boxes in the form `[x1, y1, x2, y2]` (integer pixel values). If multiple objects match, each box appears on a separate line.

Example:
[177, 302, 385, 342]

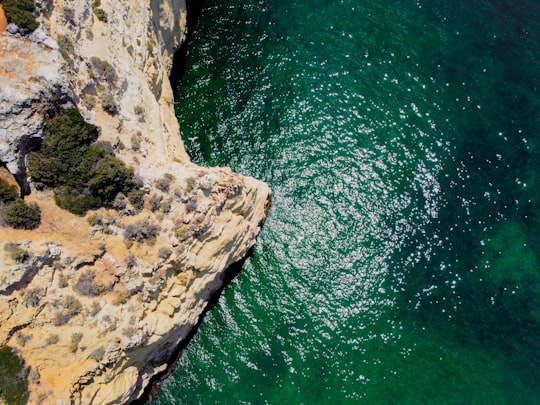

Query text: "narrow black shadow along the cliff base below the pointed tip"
[130, 248, 253, 405]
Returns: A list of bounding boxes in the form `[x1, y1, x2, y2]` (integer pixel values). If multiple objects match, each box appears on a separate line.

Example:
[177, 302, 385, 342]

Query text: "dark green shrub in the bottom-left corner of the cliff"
[0, 346, 28, 405]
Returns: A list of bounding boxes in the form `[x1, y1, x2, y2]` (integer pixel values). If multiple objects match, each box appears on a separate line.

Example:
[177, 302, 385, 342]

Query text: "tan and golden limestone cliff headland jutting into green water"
[0, 0, 271, 404]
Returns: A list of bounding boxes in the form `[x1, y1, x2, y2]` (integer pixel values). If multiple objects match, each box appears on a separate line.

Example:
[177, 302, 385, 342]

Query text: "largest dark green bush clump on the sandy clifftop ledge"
[28, 108, 135, 216]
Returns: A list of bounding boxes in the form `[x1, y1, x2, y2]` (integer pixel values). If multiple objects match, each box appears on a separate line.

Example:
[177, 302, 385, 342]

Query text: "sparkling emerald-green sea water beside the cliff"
[154, 0, 540, 404]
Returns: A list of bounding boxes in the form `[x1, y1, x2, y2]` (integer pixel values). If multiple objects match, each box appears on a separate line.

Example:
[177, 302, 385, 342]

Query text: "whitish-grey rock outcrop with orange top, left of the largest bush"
[0, 24, 74, 192]
